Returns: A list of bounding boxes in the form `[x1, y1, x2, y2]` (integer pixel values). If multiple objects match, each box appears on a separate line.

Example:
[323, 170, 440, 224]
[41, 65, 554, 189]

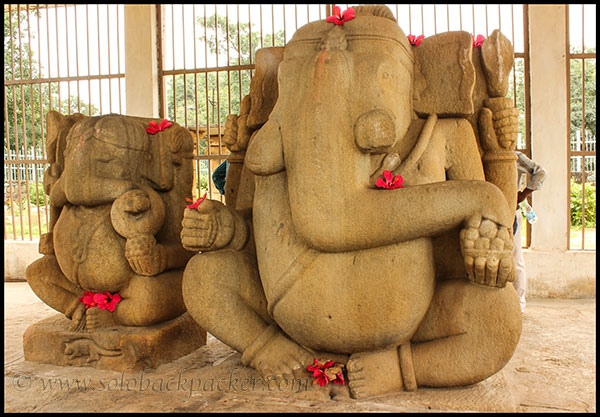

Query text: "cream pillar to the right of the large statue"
[529, 4, 568, 251]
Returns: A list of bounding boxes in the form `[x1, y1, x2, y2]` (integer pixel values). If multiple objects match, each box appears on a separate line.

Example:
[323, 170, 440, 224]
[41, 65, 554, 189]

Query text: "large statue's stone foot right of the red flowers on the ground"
[347, 348, 403, 399]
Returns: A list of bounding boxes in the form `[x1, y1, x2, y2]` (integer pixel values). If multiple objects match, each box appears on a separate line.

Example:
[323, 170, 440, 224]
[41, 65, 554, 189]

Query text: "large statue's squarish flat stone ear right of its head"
[413, 32, 475, 117]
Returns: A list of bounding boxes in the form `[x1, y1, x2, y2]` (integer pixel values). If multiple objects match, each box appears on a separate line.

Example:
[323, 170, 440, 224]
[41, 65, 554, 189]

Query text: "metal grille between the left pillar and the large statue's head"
[158, 4, 328, 201]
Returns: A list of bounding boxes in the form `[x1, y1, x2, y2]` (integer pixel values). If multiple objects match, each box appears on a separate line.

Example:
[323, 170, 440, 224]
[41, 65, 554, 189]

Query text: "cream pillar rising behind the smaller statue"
[124, 4, 159, 118]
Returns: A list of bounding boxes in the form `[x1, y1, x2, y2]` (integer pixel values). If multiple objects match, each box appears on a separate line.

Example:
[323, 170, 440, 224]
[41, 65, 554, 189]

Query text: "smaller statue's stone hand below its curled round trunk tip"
[125, 235, 167, 276]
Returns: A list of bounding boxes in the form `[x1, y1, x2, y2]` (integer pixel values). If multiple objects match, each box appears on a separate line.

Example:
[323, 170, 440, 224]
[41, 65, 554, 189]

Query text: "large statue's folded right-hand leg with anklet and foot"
[347, 279, 521, 398]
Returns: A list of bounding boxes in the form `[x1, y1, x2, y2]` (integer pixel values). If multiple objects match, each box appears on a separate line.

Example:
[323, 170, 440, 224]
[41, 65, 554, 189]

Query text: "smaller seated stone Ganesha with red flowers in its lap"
[26, 111, 193, 332]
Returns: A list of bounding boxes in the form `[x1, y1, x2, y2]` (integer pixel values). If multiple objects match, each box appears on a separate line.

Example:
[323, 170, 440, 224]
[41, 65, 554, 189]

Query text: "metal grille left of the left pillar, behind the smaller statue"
[4, 4, 125, 240]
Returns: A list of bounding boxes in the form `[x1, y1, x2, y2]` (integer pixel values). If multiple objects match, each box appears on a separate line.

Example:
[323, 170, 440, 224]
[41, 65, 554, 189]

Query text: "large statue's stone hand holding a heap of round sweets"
[460, 215, 515, 288]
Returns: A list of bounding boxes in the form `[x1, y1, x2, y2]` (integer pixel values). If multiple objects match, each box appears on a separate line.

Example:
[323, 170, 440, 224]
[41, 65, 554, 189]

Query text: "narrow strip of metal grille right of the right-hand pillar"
[565, 4, 596, 250]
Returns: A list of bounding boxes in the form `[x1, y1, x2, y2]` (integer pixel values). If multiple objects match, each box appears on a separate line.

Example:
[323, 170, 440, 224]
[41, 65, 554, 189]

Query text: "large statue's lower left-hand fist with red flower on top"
[181, 200, 235, 252]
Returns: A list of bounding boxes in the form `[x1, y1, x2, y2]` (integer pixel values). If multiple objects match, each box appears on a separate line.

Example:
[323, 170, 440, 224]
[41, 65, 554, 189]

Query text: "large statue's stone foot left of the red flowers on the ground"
[242, 324, 314, 380]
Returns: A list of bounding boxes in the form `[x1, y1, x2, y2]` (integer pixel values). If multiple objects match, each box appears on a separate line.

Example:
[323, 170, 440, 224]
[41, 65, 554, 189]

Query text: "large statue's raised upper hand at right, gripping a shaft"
[479, 97, 519, 153]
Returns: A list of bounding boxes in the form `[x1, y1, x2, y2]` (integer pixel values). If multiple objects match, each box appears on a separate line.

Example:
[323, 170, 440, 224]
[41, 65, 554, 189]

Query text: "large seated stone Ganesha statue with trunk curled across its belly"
[182, 6, 521, 398]
